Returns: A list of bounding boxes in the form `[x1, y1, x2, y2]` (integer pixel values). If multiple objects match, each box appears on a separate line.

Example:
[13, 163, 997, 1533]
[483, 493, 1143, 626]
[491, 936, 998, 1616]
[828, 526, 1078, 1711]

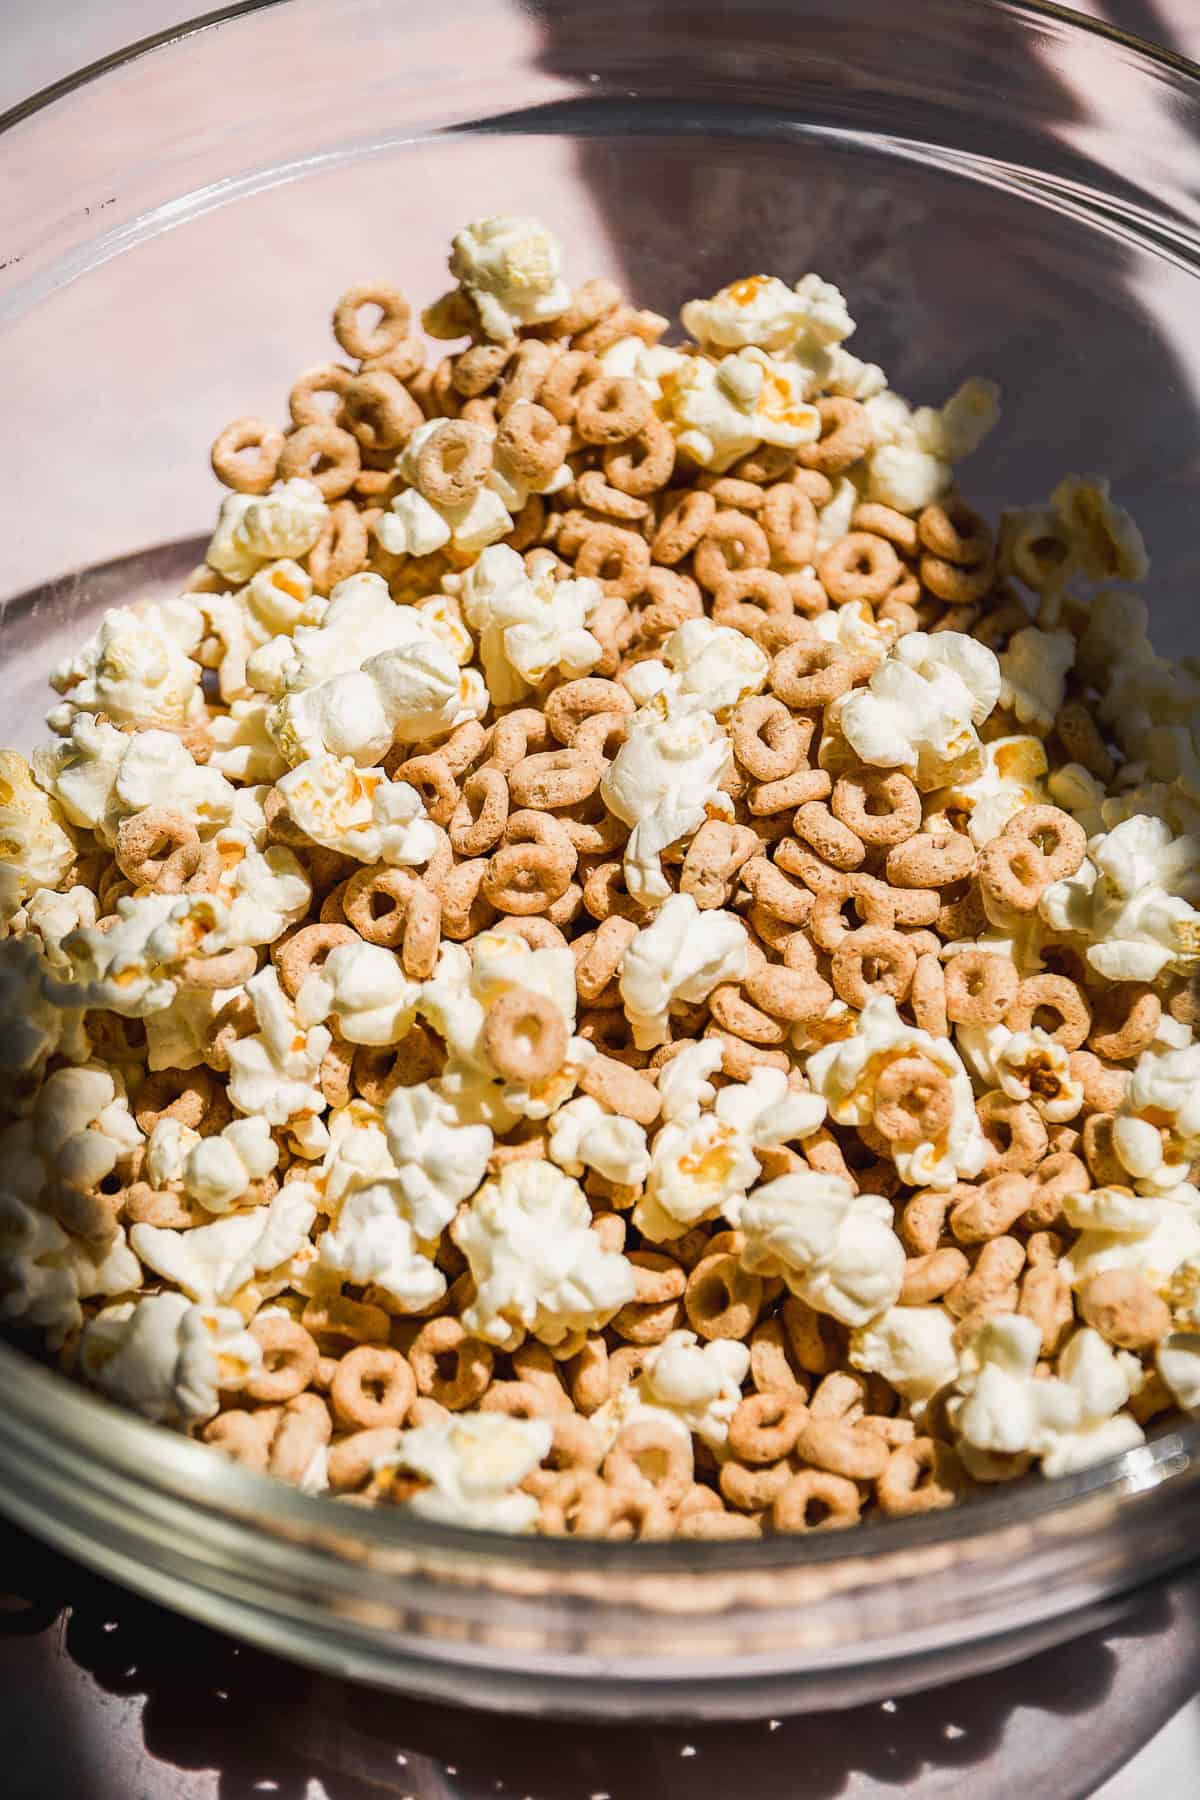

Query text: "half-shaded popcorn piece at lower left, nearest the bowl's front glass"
[79, 1292, 263, 1426]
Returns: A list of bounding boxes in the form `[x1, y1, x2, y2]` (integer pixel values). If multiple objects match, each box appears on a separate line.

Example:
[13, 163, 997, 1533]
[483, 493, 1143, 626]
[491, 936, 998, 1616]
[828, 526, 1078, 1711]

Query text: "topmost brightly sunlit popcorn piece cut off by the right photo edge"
[1038, 814, 1200, 981]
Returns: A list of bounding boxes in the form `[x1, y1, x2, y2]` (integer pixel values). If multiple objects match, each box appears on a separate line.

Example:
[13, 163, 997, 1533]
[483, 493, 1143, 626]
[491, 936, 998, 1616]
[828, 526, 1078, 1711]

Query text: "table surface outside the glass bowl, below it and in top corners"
[0, 0, 1200, 1800]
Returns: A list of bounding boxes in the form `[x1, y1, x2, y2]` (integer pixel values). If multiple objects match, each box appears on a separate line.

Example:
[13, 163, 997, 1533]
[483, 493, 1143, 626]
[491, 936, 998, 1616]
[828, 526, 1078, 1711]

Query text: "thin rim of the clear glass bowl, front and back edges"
[0, 0, 1200, 1577]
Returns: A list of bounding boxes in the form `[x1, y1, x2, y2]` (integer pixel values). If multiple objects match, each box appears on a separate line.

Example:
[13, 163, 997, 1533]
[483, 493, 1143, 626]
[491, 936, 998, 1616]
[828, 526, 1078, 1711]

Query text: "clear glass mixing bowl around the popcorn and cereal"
[0, 0, 1200, 1717]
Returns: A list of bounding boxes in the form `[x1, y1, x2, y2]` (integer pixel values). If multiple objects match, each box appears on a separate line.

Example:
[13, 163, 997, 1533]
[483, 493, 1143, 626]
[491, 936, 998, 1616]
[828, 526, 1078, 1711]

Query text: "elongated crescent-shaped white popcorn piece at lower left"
[130, 1181, 317, 1303]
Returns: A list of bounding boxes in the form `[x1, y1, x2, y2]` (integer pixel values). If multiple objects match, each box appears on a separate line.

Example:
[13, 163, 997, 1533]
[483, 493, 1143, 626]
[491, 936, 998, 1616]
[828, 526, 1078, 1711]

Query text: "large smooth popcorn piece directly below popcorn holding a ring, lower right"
[739, 1170, 905, 1325]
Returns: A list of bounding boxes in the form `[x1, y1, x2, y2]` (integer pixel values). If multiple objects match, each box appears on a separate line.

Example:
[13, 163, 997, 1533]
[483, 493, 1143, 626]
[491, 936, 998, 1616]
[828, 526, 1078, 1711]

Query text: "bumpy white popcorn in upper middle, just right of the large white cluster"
[443, 544, 603, 706]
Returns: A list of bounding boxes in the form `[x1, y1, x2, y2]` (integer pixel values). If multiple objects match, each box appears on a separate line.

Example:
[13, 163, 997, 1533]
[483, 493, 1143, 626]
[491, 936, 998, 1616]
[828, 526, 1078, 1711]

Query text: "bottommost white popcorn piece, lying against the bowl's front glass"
[376, 1413, 552, 1532]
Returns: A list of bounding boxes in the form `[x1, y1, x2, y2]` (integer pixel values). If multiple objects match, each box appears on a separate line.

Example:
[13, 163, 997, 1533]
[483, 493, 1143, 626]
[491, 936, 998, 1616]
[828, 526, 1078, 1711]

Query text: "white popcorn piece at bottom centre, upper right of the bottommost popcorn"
[592, 1332, 750, 1458]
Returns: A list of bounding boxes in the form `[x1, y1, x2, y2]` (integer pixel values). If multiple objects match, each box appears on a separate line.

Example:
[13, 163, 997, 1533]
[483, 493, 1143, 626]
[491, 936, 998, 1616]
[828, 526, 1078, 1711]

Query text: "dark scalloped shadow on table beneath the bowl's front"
[0, 1530, 1194, 1800]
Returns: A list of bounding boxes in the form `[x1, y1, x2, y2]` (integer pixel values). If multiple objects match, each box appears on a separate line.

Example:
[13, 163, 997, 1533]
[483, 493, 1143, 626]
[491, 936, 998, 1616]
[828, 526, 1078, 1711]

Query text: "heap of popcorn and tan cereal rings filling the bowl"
[0, 218, 1200, 1539]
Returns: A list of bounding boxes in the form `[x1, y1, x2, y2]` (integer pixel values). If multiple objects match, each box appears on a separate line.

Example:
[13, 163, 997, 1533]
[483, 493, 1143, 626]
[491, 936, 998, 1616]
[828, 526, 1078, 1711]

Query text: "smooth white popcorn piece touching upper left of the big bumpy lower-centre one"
[383, 1082, 495, 1238]
